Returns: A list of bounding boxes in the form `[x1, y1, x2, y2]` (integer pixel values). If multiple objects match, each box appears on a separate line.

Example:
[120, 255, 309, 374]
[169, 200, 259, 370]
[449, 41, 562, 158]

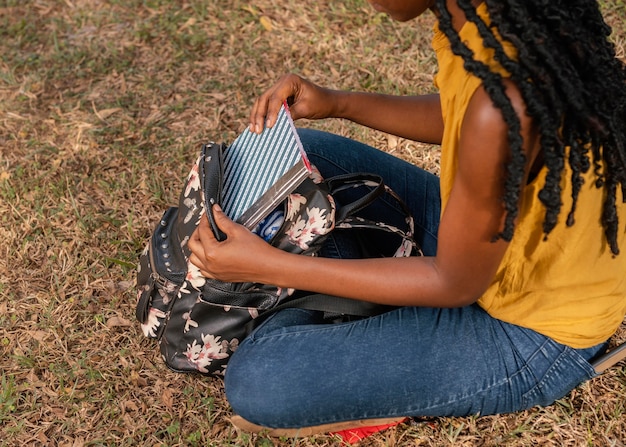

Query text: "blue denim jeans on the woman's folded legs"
[225, 130, 605, 428]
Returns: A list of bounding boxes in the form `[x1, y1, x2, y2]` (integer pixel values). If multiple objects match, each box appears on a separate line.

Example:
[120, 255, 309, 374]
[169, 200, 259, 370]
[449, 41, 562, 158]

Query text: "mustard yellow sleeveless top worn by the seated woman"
[433, 3, 626, 348]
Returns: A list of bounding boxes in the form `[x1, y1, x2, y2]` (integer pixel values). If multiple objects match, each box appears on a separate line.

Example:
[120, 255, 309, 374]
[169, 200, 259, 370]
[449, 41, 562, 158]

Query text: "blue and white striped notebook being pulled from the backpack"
[222, 104, 311, 230]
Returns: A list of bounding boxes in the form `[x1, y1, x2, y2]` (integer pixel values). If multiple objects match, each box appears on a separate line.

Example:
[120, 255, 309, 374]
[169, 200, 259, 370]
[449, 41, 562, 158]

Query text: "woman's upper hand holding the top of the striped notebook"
[250, 74, 335, 133]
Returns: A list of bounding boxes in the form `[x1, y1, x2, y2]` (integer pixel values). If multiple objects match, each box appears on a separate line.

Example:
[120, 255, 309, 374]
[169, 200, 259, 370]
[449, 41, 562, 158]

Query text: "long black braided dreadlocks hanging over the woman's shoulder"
[436, 0, 626, 255]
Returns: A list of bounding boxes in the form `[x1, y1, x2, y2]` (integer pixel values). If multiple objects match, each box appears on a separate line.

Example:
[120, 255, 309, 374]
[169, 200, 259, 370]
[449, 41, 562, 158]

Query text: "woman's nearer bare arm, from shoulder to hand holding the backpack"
[189, 79, 537, 307]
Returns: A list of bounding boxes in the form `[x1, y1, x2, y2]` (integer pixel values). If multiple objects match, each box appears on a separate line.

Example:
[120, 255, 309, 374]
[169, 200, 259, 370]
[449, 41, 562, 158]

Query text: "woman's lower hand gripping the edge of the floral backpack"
[188, 205, 276, 282]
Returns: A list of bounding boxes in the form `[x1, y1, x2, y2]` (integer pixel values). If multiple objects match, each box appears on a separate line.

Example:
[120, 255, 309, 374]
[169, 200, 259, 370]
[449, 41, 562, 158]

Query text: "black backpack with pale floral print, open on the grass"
[136, 143, 419, 375]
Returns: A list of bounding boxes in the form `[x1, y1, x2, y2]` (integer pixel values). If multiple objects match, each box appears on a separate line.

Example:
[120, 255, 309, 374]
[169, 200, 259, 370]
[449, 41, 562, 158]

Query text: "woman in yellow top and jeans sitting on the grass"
[190, 0, 626, 434]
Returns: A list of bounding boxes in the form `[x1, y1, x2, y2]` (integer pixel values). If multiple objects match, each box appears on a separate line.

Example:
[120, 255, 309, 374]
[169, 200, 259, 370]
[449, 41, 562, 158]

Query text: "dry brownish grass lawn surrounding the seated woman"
[0, 0, 626, 447]
